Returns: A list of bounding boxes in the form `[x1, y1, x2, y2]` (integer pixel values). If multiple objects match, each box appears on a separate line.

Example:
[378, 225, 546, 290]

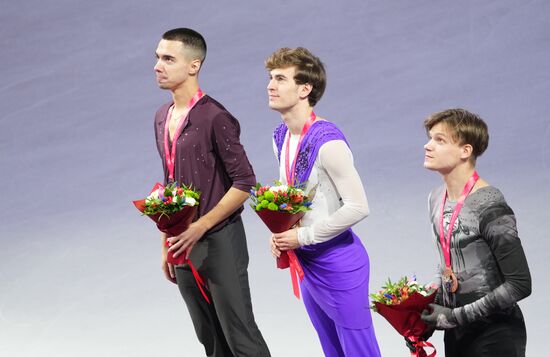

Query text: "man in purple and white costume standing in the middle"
[266, 47, 380, 357]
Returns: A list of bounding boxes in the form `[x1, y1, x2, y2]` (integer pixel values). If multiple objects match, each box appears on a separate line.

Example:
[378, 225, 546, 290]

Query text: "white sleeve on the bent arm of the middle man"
[298, 140, 369, 245]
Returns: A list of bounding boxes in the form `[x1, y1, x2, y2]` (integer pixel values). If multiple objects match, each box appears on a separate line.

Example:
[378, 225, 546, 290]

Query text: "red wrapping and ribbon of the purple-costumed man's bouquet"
[255, 209, 305, 299]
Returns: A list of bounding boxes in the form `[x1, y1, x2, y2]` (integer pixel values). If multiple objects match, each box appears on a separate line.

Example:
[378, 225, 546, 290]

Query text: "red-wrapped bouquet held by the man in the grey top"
[370, 277, 437, 357]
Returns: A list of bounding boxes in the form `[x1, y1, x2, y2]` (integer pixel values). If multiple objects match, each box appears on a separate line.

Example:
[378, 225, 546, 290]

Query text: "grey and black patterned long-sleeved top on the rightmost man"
[429, 185, 531, 325]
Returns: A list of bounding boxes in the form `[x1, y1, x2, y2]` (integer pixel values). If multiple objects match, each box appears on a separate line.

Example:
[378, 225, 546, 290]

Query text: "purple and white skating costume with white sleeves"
[273, 120, 380, 357]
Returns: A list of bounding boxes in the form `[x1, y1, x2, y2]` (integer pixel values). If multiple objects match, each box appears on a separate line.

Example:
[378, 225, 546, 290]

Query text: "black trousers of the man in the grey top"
[445, 306, 527, 357]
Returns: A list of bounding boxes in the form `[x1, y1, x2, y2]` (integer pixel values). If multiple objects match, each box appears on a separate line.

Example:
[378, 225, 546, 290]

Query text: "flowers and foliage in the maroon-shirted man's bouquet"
[143, 182, 201, 215]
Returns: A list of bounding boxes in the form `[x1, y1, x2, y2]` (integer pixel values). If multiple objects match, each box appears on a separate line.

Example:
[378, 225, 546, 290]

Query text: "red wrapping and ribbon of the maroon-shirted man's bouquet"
[133, 183, 210, 303]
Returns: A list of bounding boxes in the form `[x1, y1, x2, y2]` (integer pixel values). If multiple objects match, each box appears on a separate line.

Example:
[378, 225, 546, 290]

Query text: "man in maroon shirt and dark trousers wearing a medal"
[155, 28, 270, 357]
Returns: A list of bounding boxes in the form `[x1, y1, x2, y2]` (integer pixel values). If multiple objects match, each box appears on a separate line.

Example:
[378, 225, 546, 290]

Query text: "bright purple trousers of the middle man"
[296, 229, 380, 357]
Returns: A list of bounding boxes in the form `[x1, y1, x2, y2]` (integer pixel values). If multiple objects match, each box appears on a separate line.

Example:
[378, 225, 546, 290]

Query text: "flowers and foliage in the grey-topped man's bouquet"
[369, 276, 436, 311]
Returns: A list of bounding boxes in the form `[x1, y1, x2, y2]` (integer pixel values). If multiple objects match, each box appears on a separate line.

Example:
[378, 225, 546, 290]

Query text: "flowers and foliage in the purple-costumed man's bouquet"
[250, 181, 311, 213]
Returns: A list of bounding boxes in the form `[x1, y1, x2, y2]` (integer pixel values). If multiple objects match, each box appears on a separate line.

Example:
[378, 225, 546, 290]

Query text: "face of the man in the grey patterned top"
[424, 123, 469, 174]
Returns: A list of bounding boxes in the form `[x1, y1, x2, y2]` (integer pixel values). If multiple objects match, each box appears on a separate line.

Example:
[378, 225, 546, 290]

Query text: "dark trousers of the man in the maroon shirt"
[176, 218, 270, 357]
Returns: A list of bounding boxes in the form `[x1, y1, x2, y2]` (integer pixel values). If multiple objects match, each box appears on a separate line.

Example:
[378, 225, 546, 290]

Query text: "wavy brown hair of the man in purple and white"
[265, 47, 327, 107]
